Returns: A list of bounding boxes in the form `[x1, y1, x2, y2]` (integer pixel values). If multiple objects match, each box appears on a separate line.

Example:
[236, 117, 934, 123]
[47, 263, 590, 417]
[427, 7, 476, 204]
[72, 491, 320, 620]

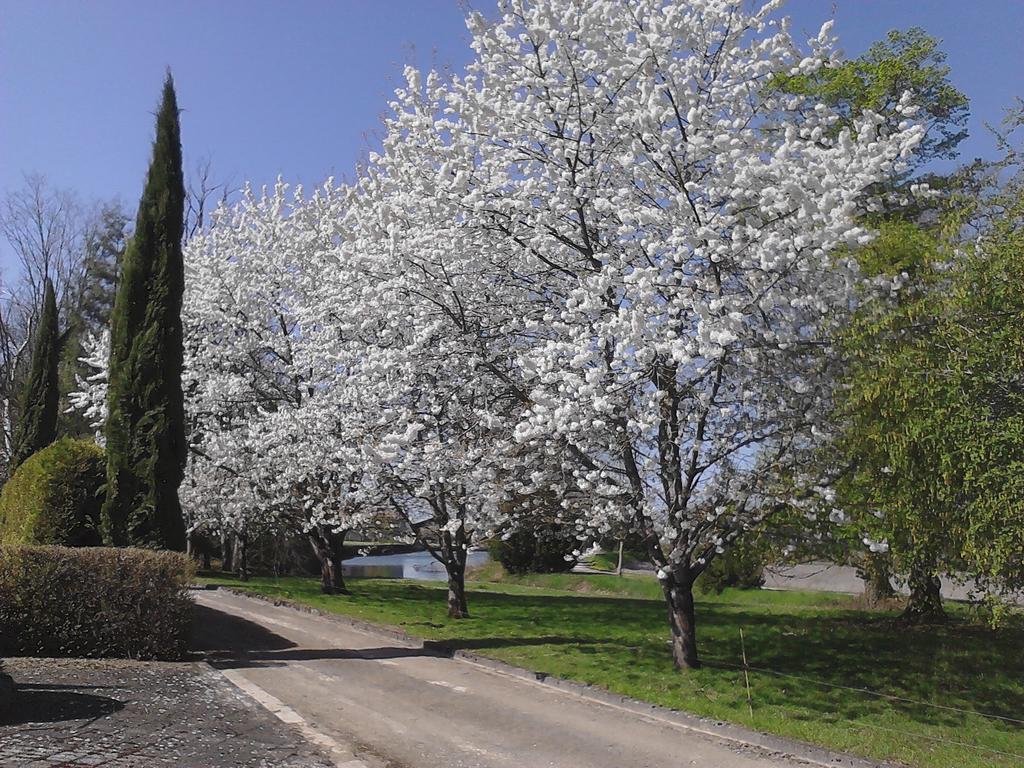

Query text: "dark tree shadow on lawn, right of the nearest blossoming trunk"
[703, 609, 1024, 730]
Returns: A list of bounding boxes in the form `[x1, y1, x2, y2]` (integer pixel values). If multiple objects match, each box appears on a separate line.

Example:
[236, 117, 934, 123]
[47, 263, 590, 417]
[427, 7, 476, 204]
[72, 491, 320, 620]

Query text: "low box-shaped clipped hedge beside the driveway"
[0, 546, 194, 659]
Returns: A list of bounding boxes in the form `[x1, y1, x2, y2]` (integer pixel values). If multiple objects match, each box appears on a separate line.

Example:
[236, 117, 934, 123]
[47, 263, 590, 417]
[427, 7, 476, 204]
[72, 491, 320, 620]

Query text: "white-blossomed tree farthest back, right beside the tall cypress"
[183, 183, 365, 592]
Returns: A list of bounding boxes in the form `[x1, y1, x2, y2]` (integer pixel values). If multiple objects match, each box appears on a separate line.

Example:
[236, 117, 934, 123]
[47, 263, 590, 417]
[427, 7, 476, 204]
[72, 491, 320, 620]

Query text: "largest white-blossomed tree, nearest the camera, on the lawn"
[370, 0, 921, 668]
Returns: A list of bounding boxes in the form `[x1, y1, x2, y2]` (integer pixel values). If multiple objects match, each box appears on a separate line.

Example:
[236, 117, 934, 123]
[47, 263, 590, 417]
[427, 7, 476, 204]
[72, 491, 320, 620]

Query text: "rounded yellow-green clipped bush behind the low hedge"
[0, 437, 106, 547]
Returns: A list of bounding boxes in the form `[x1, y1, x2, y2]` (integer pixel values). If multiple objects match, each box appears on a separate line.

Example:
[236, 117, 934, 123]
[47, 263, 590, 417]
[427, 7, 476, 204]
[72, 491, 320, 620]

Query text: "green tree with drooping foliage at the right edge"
[843, 109, 1024, 618]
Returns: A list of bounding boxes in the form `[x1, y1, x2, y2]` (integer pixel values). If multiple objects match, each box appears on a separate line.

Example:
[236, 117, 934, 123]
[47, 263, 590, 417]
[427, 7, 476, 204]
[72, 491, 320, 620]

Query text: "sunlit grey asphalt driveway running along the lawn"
[196, 591, 831, 768]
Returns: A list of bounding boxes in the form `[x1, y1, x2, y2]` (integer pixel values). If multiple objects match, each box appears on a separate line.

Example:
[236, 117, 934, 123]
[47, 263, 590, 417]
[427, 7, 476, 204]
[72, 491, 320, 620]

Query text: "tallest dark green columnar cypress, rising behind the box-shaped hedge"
[101, 73, 185, 549]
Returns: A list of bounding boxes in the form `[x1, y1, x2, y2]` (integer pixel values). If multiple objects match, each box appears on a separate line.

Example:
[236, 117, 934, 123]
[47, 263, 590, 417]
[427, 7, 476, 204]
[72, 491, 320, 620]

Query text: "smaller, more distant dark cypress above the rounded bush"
[11, 279, 60, 471]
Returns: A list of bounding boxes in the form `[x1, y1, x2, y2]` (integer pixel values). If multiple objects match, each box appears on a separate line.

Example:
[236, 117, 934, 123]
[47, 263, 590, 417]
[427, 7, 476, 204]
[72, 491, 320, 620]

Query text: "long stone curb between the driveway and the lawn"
[209, 586, 898, 768]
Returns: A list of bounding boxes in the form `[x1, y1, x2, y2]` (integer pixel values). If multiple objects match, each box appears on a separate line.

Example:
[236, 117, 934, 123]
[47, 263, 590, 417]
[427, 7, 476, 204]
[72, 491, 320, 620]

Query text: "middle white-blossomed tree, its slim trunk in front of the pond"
[342, 134, 521, 618]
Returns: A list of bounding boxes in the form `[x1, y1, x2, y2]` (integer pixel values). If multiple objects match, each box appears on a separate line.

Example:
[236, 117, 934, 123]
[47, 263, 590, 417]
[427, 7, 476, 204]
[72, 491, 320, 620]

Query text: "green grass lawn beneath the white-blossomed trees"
[204, 567, 1024, 768]
